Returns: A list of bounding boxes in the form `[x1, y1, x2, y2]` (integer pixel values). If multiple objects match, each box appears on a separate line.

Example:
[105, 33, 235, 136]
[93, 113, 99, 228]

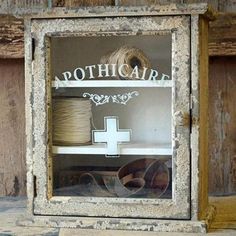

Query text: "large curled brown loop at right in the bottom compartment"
[114, 158, 169, 198]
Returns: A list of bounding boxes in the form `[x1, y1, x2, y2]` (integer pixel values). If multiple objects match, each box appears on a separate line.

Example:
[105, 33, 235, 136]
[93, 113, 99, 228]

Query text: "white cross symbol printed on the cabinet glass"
[93, 116, 131, 156]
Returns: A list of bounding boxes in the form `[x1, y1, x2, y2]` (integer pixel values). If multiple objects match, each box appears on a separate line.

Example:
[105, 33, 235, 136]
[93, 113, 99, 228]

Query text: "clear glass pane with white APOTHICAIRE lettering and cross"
[51, 34, 172, 198]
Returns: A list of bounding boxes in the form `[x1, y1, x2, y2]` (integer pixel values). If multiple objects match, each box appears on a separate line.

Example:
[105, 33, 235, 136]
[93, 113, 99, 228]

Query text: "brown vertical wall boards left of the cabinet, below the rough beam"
[0, 59, 26, 196]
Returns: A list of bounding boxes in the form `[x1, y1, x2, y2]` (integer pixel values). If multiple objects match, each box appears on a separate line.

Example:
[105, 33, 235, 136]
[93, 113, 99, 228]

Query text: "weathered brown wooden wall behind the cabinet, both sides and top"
[0, 0, 236, 196]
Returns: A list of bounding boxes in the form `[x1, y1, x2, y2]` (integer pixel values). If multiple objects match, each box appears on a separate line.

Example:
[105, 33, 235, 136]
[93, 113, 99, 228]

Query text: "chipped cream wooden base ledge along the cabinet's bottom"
[17, 216, 207, 233]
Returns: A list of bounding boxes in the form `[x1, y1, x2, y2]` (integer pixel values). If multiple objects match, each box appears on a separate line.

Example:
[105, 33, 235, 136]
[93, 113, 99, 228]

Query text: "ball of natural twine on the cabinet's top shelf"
[100, 45, 151, 79]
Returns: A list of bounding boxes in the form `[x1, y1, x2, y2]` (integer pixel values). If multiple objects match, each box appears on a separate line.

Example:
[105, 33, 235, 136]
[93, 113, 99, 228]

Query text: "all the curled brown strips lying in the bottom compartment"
[54, 157, 170, 198]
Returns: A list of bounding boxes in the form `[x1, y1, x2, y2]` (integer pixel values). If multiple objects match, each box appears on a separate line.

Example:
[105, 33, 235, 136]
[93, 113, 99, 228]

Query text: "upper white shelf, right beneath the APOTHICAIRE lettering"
[52, 80, 173, 88]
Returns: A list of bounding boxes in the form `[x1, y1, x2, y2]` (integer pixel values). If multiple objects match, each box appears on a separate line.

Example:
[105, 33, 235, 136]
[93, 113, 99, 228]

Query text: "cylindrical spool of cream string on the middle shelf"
[52, 98, 92, 146]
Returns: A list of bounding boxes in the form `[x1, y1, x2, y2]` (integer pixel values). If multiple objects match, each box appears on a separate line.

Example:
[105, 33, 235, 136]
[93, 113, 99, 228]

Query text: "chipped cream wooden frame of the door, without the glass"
[30, 16, 190, 219]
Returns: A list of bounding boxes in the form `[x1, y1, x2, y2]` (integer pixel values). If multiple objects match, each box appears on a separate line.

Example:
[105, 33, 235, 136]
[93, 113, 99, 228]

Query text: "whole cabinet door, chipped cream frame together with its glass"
[30, 16, 190, 219]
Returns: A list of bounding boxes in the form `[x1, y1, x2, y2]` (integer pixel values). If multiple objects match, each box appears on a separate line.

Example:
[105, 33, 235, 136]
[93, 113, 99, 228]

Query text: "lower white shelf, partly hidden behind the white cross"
[52, 143, 172, 155]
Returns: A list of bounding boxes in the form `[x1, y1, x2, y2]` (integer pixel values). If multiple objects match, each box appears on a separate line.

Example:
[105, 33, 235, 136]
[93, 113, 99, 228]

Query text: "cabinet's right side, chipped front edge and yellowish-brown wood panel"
[191, 16, 208, 220]
